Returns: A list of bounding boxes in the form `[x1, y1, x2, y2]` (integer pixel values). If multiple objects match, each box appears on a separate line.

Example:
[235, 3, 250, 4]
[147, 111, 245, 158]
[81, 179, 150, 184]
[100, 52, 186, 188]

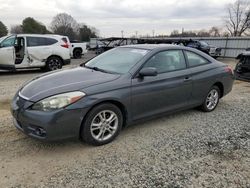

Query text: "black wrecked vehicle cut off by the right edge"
[235, 50, 250, 81]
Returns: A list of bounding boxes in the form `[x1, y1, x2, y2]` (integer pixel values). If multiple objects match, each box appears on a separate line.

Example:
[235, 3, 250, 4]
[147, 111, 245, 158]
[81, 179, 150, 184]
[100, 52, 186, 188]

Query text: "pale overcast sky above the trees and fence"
[0, 0, 234, 37]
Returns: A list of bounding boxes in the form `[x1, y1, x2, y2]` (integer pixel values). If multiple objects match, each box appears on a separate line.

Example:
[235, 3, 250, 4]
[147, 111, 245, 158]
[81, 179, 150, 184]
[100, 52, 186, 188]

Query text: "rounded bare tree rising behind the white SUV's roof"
[51, 13, 79, 40]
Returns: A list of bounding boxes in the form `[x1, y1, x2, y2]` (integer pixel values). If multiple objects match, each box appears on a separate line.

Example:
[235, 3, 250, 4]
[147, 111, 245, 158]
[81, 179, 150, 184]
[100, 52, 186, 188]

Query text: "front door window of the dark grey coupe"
[144, 50, 186, 73]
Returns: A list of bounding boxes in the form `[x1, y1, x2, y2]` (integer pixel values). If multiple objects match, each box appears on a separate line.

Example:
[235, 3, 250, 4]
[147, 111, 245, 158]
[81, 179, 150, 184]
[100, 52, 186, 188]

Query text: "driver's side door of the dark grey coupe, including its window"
[131, 50, 192, 120]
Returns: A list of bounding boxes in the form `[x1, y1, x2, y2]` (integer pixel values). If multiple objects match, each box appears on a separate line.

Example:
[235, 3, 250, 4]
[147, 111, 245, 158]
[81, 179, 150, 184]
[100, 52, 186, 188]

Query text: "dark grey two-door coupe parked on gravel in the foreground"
[11, 45, 234, 145]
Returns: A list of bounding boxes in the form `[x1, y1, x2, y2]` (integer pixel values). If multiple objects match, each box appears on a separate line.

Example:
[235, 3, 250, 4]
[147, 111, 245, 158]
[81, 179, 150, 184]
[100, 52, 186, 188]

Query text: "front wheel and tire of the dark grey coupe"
[80, 103, 123, 146]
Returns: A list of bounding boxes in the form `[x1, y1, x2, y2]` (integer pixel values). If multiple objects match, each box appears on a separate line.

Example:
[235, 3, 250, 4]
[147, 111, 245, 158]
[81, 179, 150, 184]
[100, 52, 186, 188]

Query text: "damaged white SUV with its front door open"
[0, 34, 70, 71]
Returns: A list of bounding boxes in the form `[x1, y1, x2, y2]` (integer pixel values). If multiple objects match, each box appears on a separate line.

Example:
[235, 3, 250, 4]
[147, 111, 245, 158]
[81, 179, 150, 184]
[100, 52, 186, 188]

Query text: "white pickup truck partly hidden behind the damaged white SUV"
[70, 41, 88, 59]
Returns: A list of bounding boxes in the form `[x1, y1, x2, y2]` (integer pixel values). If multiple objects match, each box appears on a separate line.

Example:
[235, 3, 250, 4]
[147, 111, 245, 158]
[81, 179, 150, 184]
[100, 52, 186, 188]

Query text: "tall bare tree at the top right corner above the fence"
[226, 0, 250, 36]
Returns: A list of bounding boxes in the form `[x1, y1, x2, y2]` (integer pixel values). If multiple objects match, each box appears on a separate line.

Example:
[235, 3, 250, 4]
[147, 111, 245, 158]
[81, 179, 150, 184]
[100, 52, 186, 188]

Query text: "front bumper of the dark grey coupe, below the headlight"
[11, 97, 88, 141]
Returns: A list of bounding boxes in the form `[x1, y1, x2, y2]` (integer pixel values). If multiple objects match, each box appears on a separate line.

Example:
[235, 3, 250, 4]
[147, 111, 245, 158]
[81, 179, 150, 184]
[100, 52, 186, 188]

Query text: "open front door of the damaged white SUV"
[0, 35, 16, 68]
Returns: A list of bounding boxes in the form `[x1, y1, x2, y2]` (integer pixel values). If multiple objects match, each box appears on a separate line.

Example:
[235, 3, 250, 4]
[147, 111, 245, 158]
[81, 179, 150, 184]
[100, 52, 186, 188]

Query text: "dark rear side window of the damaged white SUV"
[27, 37, 57, 46]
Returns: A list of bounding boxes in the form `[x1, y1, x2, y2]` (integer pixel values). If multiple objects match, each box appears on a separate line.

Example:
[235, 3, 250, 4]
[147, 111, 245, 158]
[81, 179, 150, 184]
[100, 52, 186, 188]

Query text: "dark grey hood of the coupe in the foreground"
[19, 67, 120, 102]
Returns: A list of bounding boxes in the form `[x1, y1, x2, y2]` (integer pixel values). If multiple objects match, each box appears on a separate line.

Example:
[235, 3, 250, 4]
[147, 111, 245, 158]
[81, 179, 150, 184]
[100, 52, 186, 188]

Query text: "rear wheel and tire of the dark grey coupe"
[201, 85, 221, 112]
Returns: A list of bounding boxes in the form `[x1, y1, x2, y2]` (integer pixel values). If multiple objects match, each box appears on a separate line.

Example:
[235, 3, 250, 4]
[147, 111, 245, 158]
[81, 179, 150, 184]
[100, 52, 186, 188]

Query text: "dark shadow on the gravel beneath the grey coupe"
[15, 109, 199, 154]
